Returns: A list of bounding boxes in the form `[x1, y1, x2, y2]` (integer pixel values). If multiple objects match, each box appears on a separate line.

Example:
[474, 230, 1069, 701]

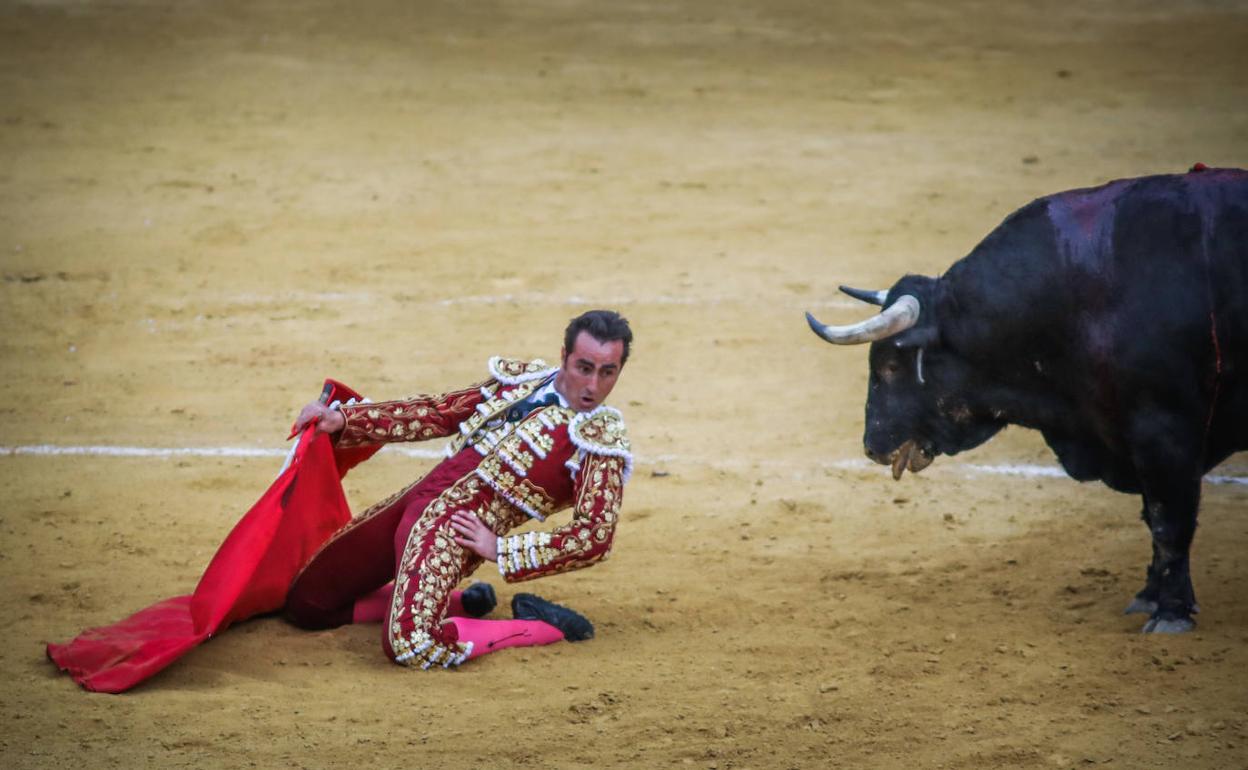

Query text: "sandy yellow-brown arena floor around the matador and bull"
[0, 0, 1248, 770]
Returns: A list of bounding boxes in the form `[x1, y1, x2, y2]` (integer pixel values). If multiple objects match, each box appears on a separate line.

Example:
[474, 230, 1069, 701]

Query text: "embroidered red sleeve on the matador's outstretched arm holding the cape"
[337, 381, 498, 448]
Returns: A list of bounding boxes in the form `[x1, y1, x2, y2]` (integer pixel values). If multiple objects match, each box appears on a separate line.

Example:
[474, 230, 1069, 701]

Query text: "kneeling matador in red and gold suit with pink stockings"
[286, 311, 633, 669]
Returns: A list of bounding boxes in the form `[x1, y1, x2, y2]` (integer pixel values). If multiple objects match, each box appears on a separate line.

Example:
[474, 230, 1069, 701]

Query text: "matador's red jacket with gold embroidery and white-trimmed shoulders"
[337, 357, 633, 583]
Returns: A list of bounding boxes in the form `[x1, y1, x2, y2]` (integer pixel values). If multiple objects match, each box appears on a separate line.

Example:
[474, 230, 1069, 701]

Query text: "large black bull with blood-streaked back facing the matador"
[807, 167, 1248, 631]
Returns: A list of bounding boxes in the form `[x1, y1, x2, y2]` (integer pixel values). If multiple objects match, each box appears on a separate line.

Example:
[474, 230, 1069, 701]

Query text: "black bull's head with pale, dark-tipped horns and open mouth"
[806, 276, 1005, 479]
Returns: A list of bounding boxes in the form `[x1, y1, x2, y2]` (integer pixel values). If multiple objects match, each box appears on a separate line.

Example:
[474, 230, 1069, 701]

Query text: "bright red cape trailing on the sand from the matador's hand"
[47, 379, 379, 693]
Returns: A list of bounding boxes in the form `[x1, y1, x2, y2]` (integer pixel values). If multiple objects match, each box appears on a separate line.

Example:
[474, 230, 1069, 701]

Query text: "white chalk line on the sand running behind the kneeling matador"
[0, 444, 1248, 487]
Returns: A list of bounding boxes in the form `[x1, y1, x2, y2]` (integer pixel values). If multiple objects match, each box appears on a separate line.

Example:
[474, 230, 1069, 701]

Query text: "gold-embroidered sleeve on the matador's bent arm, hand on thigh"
[498, 454, 624, 583]
